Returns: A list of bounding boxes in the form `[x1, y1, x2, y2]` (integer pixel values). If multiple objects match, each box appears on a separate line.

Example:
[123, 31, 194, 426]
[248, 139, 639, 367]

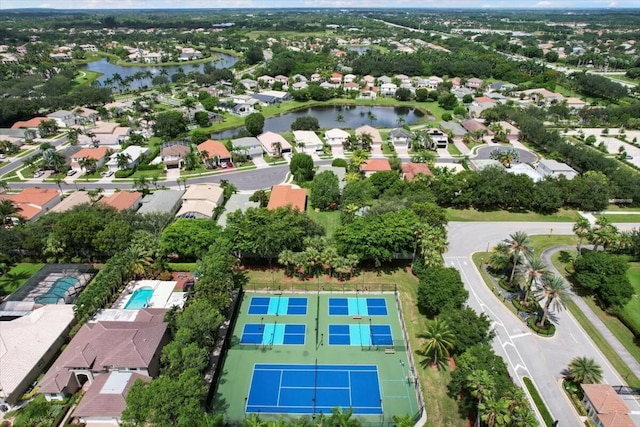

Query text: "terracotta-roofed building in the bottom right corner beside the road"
[580, 384, 635, 427]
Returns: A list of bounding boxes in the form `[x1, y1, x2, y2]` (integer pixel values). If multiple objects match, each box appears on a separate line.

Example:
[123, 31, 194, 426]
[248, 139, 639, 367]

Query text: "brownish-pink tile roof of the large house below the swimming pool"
[40, 316, 167, 394]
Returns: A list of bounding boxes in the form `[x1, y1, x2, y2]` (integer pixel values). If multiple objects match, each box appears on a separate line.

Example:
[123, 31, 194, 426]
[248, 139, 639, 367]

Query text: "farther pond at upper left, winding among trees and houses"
[82, 52, 238, 89]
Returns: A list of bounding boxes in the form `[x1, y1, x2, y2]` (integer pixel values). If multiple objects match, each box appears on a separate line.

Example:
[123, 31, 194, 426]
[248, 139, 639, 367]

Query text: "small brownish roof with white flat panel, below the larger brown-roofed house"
[73, 372, 151, 418]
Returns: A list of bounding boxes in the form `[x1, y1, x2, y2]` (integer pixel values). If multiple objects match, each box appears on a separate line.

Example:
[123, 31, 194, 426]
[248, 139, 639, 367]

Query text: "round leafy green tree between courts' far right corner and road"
[418, 266, 469, 317]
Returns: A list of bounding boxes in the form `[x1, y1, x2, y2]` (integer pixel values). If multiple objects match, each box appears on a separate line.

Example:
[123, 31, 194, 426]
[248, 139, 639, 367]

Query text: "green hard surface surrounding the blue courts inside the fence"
[214, 292, 419, 422]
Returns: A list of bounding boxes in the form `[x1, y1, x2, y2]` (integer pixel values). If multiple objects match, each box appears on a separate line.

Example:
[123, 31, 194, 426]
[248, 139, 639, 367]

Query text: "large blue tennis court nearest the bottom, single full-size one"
[245, 364, 382, 415]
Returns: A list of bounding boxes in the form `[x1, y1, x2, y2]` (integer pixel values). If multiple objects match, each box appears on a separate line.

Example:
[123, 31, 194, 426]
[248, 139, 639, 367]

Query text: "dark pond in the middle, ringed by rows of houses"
[211, 105, 424, 139]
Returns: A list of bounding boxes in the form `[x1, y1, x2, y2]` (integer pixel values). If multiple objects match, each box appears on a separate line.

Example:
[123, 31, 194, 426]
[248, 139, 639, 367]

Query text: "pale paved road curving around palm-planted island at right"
[444, 222, 640, 427]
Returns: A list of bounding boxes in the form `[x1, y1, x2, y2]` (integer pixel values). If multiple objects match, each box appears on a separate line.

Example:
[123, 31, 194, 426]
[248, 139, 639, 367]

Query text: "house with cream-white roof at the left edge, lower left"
[0, 304, 74, 405]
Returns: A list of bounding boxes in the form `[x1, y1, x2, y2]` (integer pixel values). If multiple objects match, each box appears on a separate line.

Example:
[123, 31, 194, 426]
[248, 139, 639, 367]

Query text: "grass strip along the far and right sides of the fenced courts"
[248, 268, 467, 427]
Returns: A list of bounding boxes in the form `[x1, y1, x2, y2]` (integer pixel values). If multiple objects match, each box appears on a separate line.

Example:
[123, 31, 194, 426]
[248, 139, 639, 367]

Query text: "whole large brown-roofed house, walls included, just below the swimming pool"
[38, 309, 169, 401]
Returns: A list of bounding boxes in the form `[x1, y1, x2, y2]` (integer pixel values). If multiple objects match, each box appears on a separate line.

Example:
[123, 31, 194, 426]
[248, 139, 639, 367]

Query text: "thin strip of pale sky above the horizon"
[0, 0, 640, 9]
